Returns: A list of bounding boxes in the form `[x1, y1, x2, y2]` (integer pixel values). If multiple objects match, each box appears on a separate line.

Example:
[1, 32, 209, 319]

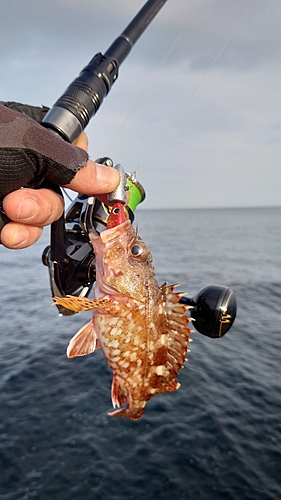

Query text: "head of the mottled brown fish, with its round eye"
[90, 220, 156, 302]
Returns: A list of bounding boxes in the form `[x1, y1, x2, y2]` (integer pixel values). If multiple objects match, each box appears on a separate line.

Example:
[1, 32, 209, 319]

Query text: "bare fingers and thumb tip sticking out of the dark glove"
[1, 132, 119, 249]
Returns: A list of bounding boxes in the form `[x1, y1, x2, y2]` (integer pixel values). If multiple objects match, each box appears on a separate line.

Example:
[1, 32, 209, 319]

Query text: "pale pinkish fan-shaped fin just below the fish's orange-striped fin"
[66, 320, 99, 358]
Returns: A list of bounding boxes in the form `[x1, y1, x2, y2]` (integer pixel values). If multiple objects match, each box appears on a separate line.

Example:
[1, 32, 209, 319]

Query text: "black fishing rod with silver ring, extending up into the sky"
[42, 0, 167, 142]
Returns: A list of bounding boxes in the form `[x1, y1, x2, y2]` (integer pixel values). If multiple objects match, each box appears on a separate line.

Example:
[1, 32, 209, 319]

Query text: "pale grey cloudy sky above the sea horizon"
[0, 0, 281, 209]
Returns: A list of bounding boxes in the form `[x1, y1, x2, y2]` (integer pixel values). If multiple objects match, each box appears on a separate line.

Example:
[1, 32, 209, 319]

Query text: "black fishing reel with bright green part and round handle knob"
[42, 158, 237, 338]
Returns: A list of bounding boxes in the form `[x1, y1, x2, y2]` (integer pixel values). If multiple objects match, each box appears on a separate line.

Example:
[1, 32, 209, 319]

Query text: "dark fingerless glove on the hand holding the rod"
[0, 102, 88, 198]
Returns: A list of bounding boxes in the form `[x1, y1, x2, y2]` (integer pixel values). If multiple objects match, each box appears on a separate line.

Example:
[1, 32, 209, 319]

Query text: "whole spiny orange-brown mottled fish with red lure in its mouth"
[54, 202, 192, 420]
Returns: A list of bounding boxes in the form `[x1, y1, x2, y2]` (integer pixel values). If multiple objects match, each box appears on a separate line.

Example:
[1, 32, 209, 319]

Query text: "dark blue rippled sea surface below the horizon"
[0, 208, 281, 500]
